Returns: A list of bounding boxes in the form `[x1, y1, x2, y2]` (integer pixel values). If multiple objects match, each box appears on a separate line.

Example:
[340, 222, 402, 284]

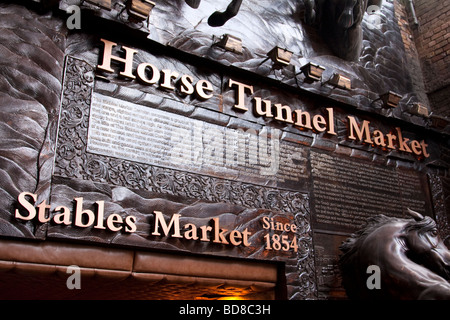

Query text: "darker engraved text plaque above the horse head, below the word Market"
[311, 152, 431, 231]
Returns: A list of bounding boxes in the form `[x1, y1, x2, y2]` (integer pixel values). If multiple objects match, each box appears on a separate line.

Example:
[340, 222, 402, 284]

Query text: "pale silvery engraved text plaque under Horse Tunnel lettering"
[87, 93, 308, 182]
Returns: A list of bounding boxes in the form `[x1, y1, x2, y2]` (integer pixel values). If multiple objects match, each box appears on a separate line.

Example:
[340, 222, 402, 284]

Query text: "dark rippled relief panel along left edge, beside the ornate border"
[0, 4, 65, 237]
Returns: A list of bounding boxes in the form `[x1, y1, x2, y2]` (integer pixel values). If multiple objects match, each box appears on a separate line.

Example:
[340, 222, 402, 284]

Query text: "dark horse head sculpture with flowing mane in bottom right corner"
[339, 209, 450, 300]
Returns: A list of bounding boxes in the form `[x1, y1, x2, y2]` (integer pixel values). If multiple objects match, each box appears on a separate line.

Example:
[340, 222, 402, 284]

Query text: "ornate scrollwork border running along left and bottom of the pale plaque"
[54, 56, 317, 299]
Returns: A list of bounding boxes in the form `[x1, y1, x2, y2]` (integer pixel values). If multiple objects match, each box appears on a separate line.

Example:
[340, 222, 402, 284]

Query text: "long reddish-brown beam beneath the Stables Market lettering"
[0, 240, 277, 288]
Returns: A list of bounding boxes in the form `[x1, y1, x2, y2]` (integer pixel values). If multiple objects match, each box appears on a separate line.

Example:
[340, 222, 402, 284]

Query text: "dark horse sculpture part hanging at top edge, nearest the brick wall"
[304, 0, 382, 61]
